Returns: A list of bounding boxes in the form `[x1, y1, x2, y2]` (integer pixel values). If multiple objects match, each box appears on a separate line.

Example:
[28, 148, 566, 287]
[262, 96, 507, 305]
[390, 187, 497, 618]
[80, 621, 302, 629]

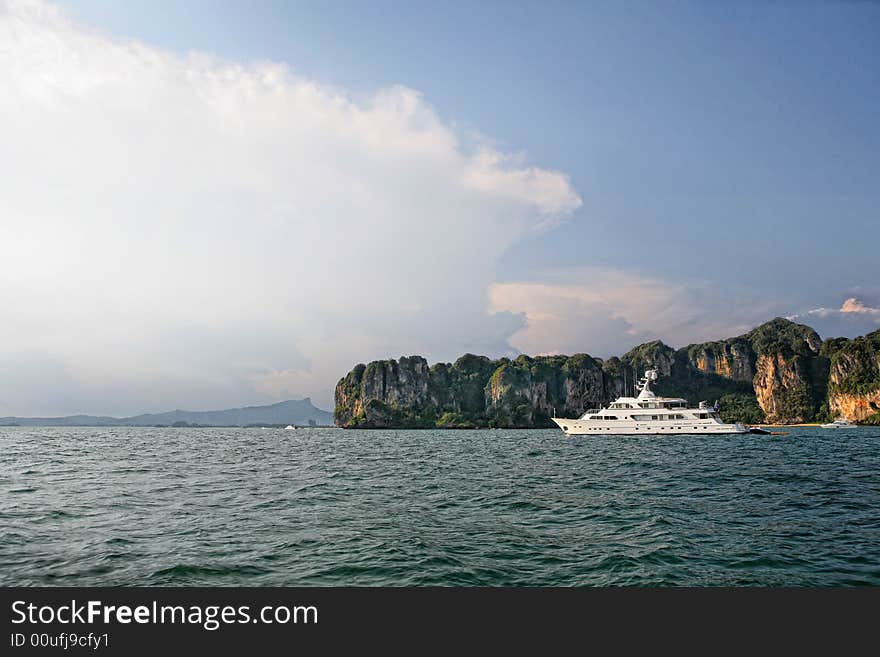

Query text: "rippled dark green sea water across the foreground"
[0, 427, 880, 586]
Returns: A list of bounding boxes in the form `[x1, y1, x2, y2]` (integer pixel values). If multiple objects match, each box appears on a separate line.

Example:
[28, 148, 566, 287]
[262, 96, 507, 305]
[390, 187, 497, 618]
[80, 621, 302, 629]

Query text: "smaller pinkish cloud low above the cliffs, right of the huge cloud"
[490, 267, 772, 357]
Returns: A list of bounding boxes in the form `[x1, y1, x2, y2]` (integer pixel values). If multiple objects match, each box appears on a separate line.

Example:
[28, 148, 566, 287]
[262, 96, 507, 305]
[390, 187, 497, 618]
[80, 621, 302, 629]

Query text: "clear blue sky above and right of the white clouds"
[63, 0, 880, 302]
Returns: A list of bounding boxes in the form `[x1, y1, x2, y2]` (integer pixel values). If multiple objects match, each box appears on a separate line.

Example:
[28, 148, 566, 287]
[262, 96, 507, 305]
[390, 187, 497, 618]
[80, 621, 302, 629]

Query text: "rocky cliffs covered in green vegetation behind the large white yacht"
[336, 318, 880, 428]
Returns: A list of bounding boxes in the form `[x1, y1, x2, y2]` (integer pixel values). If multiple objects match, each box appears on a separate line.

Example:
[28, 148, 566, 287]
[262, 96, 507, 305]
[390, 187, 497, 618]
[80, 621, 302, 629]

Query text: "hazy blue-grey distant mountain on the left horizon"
[0, 397, 333, 427]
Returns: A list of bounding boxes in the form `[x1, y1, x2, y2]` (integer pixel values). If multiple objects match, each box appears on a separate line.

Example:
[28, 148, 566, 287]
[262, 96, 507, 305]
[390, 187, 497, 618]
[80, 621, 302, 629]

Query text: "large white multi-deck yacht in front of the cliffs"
[551, 370, 749, 436]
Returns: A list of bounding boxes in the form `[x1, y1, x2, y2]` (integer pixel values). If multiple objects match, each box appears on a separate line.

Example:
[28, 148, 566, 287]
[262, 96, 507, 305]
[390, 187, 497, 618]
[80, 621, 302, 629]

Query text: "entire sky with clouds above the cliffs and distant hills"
[0, 0, 880, 416]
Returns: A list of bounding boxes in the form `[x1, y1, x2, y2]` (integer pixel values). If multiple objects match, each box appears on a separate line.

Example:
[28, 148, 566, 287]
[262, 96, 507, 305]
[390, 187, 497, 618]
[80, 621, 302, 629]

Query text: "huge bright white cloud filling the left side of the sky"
[0, 0, 581, 414]
